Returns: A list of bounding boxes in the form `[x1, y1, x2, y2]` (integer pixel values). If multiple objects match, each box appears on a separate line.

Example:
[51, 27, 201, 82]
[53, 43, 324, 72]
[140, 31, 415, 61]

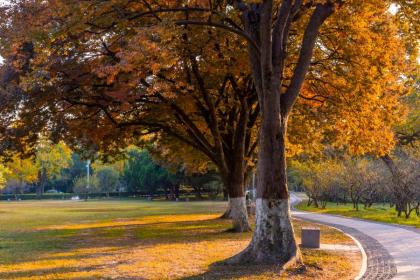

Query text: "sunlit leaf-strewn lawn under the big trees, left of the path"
[0, 200, 360, 279]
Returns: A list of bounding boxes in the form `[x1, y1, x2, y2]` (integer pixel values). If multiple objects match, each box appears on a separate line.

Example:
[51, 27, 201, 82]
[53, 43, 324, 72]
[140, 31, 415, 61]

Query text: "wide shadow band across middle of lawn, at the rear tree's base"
[0, 219, 249, 265]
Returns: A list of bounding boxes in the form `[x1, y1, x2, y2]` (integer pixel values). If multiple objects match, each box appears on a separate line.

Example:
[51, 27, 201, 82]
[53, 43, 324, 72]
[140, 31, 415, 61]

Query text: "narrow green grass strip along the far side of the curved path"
[296, 201, 420, 228]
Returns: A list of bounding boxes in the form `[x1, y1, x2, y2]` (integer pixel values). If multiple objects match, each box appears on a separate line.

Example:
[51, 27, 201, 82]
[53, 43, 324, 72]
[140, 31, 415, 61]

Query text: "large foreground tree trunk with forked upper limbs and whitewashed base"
[220, 1, 334, 266]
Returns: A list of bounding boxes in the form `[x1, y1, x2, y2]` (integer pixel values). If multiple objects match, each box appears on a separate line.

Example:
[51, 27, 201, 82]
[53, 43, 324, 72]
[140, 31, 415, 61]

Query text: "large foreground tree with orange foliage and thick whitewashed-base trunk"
[3, 0, 414, 264]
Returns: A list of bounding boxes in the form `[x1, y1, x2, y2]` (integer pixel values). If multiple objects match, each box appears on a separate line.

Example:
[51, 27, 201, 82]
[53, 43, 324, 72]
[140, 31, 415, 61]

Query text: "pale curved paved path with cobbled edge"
[290, 194, 420, 280]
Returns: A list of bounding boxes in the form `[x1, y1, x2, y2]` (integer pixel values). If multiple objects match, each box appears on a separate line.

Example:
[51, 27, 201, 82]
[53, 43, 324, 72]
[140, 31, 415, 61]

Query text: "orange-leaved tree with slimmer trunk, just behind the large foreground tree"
[0, 3, 259, 231]
